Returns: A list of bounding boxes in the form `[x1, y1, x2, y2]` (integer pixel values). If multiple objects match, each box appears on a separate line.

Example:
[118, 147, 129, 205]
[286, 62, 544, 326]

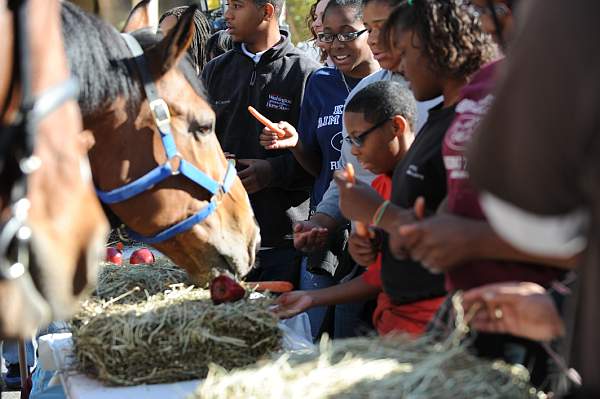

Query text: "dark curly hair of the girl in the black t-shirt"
[381, 0, 497, 79]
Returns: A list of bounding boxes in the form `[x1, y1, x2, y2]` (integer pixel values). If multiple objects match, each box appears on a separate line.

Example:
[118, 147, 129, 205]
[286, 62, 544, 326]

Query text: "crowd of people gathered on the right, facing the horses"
[2, 0, 600, 397]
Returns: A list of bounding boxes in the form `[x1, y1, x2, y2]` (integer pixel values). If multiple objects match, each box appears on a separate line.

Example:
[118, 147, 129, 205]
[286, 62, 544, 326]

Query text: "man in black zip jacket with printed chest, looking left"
[202, 0, 319, 284]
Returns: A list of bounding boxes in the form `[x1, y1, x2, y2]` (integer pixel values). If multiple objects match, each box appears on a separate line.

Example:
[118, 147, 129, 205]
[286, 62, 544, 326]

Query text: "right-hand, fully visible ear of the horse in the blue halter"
[158, 6, 197, 73]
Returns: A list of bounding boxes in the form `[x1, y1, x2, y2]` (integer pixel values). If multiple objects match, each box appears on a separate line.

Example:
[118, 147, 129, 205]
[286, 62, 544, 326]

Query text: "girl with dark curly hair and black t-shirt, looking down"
[336, 0, 495, 333]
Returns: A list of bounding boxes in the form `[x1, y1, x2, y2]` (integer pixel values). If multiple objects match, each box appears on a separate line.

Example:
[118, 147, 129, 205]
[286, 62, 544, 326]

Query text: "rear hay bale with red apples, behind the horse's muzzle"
[94, 258, 193, 303]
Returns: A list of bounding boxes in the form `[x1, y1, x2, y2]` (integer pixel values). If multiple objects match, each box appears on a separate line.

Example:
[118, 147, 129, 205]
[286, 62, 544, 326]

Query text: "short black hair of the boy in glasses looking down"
[344, 80, 417, 130]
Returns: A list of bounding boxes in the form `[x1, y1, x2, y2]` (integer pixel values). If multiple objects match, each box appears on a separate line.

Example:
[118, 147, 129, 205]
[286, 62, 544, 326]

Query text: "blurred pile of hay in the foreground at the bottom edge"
[194, 296, 545, 399]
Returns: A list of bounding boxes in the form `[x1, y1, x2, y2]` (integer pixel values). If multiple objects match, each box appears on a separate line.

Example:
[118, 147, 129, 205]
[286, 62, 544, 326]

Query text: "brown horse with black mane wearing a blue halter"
[62, 1, 260, 283]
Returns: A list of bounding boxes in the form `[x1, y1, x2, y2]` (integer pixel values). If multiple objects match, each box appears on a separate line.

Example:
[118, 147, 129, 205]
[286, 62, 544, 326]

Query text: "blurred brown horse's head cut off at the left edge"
[0, 0, 108, 339]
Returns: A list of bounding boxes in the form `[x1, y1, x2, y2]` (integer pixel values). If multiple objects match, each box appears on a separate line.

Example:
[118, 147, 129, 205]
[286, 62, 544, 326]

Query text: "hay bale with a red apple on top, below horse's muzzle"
[71, 285, 281, 385]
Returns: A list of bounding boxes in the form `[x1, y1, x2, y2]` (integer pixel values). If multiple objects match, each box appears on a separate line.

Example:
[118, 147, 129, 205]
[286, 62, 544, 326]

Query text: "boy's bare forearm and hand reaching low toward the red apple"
[274, 276, 380, 319]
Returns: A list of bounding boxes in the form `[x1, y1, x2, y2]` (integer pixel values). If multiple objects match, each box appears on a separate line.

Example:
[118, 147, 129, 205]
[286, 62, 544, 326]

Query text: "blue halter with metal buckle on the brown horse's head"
[96, 33, 236, 244]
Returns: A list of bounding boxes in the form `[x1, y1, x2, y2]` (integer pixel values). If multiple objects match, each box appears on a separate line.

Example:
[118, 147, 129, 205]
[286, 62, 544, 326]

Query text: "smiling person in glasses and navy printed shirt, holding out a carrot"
[260, 0, 379, 337]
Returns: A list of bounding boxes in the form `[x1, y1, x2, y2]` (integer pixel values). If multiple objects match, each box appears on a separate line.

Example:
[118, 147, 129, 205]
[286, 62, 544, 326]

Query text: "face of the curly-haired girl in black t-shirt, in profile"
[392, 30, 442, 101]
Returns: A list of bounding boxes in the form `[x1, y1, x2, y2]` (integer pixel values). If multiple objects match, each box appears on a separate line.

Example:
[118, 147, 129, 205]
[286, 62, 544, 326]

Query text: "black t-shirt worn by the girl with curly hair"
[381, 104, 454, 305]
